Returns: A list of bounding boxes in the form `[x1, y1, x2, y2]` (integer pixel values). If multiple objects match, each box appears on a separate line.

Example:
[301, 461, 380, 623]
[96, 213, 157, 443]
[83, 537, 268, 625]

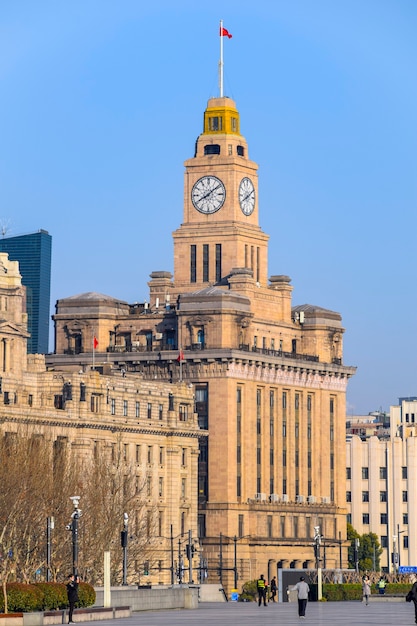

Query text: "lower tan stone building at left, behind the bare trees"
[0, 253, 202, 583]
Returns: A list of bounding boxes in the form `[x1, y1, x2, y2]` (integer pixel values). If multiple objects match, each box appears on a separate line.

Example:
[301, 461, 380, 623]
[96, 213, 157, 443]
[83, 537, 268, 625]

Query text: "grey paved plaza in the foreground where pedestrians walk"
[84, 601, 414, 626]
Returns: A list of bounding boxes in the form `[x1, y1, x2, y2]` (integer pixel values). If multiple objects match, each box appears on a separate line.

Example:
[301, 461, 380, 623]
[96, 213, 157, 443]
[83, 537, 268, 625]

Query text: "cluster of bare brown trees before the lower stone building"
[0, 426, 157, 600]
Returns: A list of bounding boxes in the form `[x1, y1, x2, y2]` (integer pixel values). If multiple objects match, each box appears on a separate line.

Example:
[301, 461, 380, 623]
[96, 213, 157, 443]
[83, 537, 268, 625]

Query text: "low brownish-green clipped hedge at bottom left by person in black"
[0, 583, 96, 613]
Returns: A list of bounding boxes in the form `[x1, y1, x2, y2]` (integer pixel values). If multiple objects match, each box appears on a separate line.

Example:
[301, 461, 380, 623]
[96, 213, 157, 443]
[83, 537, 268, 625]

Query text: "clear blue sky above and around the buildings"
[0, 0, 417, 414]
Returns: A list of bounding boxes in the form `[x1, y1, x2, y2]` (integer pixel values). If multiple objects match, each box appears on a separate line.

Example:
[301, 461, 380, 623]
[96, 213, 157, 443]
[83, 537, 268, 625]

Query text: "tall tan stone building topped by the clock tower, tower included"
[48, 97, 355, 588]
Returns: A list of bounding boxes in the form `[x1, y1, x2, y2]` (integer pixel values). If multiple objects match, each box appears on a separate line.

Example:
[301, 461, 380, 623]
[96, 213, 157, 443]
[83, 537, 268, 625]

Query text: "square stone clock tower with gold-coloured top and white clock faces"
[173, 97, 268, 291]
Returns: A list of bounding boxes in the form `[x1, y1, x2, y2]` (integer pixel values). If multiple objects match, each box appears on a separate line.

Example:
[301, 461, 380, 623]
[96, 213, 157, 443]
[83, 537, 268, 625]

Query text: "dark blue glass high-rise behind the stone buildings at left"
[0, 230, 52, 354]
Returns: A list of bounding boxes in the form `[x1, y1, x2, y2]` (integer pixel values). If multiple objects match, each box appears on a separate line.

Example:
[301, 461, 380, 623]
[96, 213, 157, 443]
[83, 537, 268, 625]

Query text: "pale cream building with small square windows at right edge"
[346, 398, 417, 572]
